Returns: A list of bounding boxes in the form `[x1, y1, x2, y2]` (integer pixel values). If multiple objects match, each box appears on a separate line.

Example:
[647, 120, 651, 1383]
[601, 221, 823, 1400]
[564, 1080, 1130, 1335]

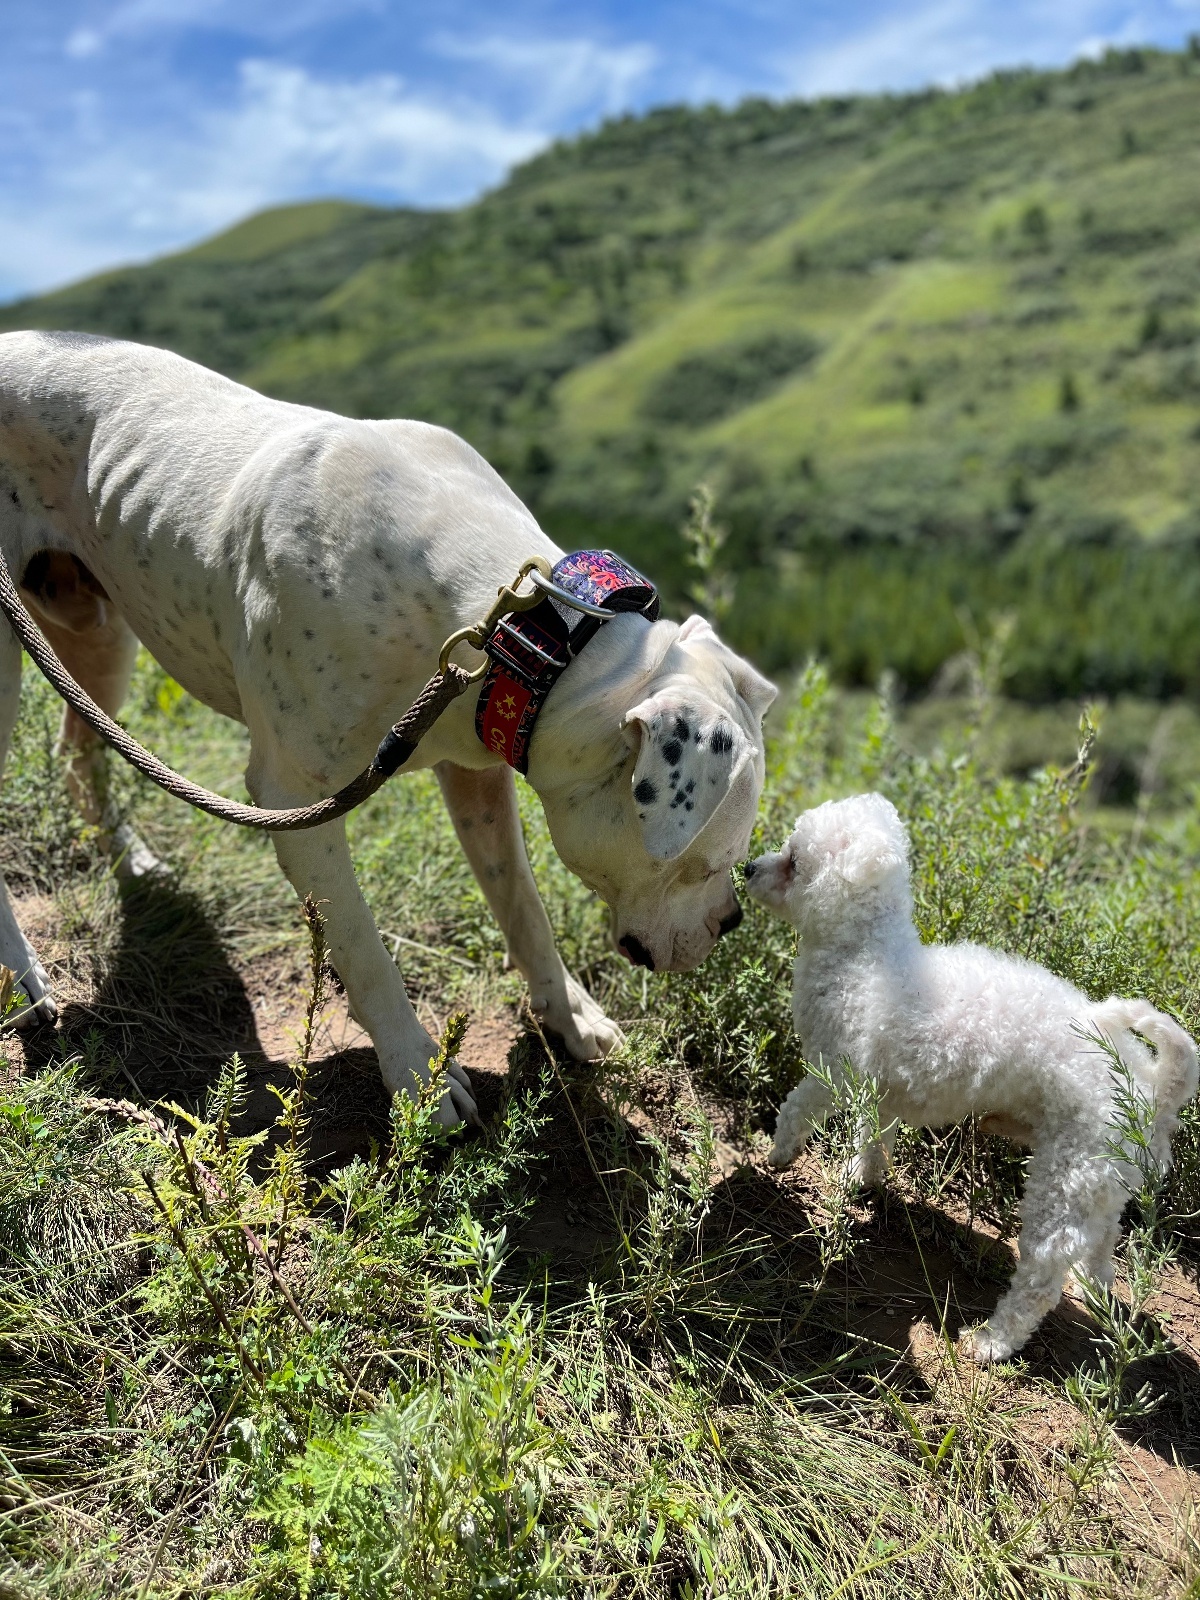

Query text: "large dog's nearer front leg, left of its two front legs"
[254, 762, 477, 1126]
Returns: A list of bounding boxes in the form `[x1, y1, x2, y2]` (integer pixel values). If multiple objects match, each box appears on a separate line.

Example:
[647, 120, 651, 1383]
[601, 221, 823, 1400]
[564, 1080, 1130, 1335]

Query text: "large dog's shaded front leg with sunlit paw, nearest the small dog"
[435, 762, 621, 1061]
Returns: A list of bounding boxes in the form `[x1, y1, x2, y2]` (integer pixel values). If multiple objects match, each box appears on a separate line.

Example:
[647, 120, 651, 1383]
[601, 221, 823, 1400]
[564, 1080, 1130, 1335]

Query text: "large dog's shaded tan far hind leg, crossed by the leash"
[38, 605, 163, 878]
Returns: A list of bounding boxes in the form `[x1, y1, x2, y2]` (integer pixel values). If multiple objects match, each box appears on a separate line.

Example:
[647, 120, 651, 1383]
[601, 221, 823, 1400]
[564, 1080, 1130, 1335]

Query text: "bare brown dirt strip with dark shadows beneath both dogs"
[5, 891, 1200, 1523]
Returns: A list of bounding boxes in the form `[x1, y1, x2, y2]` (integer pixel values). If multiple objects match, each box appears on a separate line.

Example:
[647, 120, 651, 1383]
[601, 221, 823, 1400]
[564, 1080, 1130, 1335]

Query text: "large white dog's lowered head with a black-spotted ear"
[530, 616, 776, 971]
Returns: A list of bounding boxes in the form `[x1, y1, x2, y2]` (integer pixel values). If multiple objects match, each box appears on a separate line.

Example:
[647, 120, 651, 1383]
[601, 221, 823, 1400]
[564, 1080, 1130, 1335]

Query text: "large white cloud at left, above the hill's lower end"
[0, 61, 549, 294]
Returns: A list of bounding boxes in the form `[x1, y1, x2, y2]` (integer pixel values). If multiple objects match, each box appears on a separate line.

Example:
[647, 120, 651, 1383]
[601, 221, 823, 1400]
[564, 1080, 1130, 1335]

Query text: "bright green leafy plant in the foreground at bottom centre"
[258, 1219, 570, 1600]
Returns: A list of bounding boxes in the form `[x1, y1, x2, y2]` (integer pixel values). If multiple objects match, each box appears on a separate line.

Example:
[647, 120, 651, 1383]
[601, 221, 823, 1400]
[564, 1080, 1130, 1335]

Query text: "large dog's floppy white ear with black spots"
[622, 694, 757, 861]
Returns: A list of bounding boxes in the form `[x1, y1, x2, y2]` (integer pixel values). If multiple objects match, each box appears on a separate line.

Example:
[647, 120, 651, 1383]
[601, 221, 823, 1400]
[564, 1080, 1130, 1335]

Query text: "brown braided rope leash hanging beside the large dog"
[0, 555, 472, 834]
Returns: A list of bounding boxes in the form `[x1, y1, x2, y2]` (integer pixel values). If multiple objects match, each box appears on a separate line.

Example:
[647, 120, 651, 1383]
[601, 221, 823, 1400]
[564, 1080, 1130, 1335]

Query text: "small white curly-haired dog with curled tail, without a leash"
[746, 794, 1197, 1362]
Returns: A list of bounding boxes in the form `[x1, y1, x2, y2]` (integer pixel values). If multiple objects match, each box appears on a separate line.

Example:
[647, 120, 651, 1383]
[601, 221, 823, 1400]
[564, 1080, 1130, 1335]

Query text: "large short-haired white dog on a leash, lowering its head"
[0, 333, 774, 1122]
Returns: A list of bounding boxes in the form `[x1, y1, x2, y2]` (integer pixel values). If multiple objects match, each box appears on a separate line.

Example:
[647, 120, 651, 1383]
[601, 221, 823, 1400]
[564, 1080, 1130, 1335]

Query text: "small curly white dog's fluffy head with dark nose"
[746, 794, 909, 930]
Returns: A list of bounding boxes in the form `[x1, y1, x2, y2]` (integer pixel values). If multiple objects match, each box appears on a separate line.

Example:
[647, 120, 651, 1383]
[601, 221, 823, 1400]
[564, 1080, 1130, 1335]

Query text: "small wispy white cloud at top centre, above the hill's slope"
[432, 34, 658, 122]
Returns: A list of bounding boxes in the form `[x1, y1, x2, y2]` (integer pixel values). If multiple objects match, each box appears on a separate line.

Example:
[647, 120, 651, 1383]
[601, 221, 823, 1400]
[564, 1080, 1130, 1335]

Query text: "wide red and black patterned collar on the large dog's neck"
[475, 550, 658, 773]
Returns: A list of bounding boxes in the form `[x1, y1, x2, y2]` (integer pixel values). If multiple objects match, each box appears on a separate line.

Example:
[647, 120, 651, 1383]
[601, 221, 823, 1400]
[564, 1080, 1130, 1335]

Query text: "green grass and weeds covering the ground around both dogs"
[0, 667, 1200, 1600]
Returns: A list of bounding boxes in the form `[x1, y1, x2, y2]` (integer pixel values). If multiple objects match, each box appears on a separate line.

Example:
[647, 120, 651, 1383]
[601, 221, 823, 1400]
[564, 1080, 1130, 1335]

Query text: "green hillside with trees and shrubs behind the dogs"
[0, 50, 1200, 696]
